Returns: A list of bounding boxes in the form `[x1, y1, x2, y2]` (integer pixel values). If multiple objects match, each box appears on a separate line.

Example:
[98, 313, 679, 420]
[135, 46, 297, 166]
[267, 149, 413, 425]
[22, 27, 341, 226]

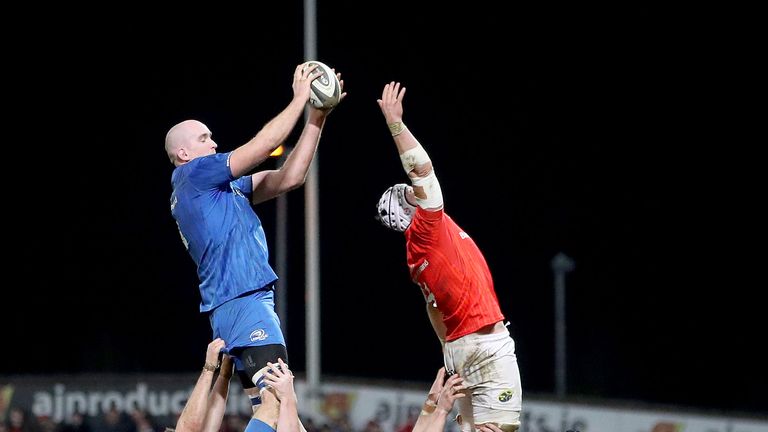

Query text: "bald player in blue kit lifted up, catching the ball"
[165, 65, 346, 412]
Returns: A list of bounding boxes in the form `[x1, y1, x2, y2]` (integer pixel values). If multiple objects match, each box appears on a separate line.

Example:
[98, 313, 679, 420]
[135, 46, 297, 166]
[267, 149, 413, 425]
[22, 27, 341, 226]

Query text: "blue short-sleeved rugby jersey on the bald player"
[171, 153, 277, 312]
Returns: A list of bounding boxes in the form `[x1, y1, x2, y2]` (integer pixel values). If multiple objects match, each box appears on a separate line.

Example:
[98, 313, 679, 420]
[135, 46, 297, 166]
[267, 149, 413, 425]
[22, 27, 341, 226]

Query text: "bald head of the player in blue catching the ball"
[165, 120, 218, 166]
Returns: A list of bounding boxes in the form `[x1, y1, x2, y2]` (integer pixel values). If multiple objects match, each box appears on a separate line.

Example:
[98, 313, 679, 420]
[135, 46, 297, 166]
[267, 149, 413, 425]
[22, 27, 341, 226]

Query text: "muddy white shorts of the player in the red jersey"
[444, 328, 523, 432]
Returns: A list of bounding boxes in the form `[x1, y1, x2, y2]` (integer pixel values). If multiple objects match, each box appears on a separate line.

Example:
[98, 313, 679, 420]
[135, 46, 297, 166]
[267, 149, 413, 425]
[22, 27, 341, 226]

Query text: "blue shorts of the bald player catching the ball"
[209, 289, 285, 362]
